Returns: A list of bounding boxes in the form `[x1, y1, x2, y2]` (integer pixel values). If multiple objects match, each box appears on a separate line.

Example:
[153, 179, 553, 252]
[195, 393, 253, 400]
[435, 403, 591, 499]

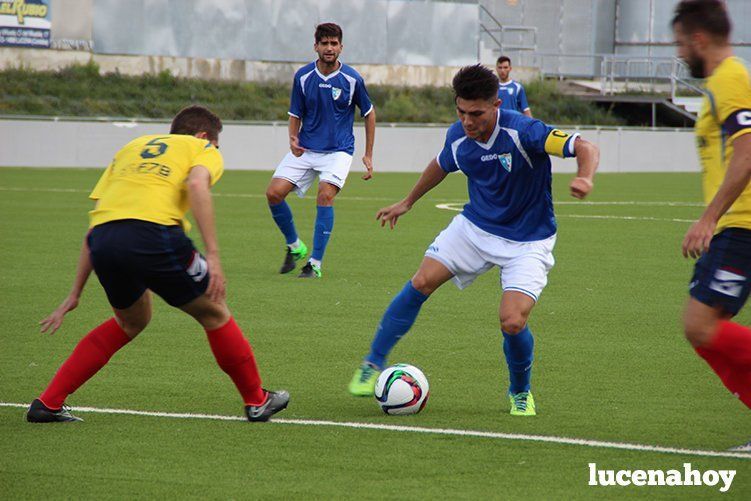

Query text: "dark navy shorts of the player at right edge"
[689, 228, 751, 315]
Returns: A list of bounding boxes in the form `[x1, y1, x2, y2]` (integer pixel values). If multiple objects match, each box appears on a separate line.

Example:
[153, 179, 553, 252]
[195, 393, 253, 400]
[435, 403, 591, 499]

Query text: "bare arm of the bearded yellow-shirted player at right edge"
[682, 134, 751, 258]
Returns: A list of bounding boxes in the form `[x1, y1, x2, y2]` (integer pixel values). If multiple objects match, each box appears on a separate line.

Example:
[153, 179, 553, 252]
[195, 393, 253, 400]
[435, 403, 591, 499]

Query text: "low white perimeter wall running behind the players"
[0, 120, 699, 172]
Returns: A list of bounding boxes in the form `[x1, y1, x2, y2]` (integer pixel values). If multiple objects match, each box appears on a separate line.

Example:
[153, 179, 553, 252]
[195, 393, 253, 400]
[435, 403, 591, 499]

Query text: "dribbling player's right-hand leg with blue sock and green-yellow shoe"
[498, 290, 536, 416]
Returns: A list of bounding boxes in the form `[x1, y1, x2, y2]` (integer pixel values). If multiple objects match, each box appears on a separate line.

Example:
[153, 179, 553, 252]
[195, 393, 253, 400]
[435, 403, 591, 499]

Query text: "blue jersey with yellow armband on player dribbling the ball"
[436, 110, 578, 242]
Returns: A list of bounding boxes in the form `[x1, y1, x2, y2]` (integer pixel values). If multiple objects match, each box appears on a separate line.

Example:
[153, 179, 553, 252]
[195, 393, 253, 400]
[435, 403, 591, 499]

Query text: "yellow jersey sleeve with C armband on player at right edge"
[707, 64, 751, 140]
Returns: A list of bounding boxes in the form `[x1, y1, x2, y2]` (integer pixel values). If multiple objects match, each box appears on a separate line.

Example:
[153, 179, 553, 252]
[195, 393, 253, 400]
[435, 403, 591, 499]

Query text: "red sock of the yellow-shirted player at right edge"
[696, 321, 751, 408]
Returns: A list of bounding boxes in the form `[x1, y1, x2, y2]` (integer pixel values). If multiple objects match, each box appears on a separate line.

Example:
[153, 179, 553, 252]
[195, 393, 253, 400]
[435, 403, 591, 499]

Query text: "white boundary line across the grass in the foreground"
[0, 402, 751, 459]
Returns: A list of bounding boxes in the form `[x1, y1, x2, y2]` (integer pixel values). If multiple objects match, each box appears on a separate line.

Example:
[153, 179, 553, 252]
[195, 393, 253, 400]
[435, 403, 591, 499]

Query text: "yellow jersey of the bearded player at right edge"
[696, 57, 751, 232]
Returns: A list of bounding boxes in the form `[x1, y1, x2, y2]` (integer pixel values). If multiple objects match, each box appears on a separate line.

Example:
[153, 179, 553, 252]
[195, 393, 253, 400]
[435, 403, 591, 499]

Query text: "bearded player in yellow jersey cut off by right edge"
[673, 0, 751, 407]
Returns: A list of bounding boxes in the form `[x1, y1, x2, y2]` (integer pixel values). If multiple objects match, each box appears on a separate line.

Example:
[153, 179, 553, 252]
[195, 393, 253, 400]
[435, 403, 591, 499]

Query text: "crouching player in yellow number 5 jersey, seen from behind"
[26, 106, 289, 423]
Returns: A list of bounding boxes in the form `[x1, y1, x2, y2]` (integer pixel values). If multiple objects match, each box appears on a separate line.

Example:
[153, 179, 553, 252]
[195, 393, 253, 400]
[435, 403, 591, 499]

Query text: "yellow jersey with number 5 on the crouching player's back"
[89, 134, 224, 231]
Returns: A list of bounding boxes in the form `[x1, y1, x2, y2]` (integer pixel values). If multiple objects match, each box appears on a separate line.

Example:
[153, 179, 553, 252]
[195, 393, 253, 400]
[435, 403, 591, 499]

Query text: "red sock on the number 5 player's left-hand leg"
[39, 318, 130, 409]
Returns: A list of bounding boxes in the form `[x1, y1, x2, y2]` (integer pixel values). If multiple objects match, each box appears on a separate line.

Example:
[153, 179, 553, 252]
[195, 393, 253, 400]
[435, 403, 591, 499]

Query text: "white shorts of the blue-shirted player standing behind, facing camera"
[273, 151, 352, 198]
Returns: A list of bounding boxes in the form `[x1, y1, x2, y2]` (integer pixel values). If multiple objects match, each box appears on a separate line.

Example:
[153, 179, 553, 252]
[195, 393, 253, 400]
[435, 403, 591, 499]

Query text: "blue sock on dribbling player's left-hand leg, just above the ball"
[365, 281, 429, 369]
